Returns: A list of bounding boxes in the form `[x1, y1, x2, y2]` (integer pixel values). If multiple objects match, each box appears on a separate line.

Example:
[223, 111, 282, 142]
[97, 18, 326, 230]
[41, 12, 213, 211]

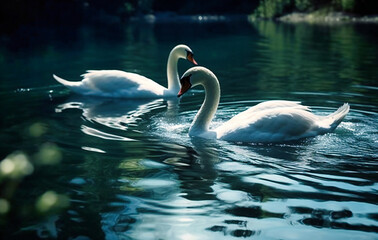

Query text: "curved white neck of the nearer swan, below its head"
[189, 74, 220, 138]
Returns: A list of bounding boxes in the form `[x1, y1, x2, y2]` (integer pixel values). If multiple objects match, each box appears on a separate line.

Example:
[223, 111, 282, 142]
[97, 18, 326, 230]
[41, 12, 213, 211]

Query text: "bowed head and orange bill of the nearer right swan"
[177, 66, 218, 97]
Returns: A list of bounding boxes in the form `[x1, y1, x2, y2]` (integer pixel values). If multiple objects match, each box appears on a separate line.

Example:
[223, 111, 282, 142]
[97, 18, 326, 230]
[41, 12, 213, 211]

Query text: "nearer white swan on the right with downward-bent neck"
[178, 67, 349, 143]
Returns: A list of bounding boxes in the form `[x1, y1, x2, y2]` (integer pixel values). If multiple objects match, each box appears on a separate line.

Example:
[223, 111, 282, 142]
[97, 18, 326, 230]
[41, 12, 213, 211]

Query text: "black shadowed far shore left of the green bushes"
[0, 0, 259, 27]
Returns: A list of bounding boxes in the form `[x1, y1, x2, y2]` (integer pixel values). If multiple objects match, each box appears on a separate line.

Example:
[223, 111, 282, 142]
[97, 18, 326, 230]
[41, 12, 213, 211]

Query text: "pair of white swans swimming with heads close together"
[54, 45, 349, 143]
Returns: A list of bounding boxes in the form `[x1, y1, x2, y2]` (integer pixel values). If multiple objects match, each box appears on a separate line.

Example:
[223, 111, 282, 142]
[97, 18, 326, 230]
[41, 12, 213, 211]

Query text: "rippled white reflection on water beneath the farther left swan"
[55, 95, 179, 141]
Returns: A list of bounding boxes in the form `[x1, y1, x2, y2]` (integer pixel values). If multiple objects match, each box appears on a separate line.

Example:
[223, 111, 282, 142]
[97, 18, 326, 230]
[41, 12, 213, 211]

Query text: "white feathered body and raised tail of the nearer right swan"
[216, 101, 349, 142]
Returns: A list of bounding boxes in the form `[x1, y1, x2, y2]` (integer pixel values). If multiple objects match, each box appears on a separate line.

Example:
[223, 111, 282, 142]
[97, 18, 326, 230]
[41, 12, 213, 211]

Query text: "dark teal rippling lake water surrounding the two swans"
[0, 19, 378, 240]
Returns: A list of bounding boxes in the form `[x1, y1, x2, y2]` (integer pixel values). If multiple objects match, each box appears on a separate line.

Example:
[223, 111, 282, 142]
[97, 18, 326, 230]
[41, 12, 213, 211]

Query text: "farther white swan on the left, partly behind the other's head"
[53, 44, 197, 98]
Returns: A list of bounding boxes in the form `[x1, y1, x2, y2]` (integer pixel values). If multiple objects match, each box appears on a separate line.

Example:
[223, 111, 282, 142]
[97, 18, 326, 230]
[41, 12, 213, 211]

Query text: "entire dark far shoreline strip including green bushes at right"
[0, 0, 378, 30]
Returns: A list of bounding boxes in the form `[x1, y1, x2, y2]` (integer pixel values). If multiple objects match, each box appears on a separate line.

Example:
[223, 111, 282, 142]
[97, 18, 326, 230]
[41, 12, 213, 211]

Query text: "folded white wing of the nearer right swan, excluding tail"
[216, 107, 318, 142]
